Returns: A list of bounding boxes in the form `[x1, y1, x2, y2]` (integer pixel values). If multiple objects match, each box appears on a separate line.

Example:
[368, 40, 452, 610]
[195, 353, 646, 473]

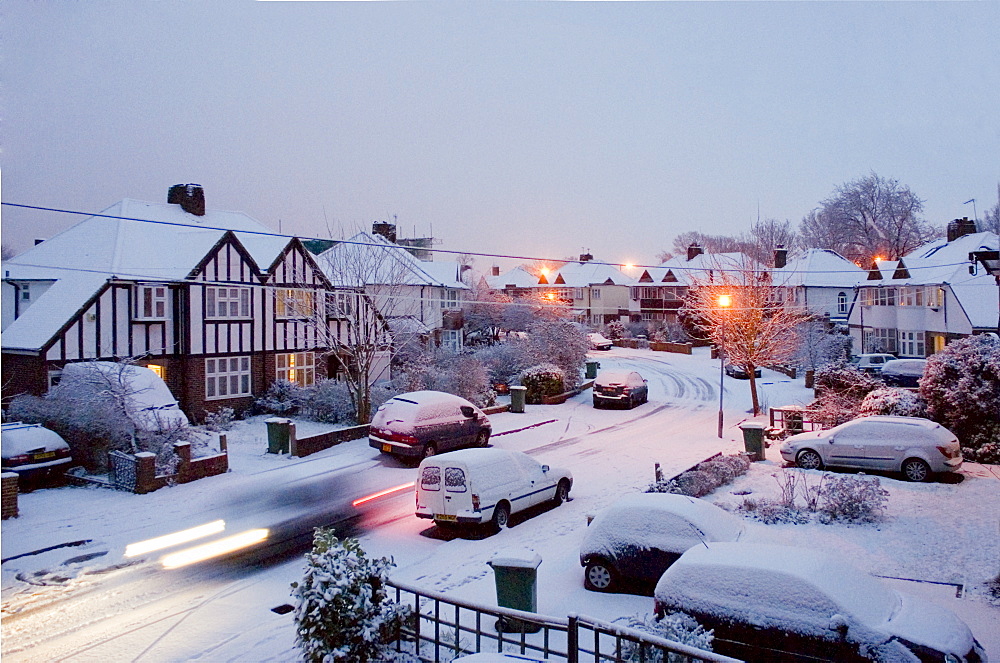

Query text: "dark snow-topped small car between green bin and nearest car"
[580, 493, 744, 592]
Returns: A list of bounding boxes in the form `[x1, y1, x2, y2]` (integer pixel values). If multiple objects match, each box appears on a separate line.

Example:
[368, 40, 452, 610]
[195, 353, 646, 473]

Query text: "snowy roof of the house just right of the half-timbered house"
[316, 232, 468, 289]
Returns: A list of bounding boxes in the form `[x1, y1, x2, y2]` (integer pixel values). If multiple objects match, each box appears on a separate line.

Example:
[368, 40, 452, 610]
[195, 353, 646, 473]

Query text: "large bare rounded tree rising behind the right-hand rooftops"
[800, 173, 938, 264]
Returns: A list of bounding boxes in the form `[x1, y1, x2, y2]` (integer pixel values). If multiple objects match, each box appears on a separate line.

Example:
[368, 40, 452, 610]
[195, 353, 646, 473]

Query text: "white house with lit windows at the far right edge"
[849, 220, 1000, 357]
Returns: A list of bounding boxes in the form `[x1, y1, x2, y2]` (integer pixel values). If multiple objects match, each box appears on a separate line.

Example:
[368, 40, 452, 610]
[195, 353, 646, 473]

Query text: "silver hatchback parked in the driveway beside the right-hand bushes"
[781, 415, 962, 481]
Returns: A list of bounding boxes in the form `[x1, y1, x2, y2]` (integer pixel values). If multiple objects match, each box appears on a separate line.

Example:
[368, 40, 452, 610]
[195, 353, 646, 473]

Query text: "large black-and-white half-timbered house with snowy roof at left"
[2, 185, 387, 420]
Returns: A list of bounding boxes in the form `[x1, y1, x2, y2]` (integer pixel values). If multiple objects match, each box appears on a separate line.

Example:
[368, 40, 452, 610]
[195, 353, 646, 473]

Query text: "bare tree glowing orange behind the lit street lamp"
[684, 259, 810, 415]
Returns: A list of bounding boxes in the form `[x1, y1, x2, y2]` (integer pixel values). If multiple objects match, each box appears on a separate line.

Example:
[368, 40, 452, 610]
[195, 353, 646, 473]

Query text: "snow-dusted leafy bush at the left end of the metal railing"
[292, 528, 410, 663]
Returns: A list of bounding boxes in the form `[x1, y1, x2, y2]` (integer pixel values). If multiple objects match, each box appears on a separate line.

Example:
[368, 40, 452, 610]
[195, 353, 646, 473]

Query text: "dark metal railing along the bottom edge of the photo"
[388, 581, 738, 663]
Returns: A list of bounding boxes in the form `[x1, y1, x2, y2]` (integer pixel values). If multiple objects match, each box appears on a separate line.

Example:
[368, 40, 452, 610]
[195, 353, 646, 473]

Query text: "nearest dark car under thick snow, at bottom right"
[654, 542, 986, 663]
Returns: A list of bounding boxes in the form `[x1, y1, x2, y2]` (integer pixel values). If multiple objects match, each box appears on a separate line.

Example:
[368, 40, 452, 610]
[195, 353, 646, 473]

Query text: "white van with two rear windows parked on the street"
[416, 447, 573, 529]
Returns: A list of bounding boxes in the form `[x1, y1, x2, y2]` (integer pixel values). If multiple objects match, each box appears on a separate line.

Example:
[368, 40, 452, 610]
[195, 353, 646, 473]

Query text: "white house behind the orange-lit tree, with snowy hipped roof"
[771, 248, 867, 324]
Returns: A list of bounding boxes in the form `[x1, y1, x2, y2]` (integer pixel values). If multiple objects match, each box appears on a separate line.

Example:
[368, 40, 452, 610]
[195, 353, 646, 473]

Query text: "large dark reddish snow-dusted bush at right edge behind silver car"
[920, 334, 1000, 462]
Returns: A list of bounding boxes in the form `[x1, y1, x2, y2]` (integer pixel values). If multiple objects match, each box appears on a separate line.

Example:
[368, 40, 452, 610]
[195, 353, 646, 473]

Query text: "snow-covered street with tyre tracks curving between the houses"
[2, 348, 1000, 662]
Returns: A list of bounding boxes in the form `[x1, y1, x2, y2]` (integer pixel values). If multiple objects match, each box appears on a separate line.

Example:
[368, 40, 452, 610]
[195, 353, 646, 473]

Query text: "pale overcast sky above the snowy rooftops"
[0, 0, 1000, 269]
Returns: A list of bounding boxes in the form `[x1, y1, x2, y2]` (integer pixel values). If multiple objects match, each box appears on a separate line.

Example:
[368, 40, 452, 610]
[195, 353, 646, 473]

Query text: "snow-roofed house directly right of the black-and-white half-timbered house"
[316, 223, 469, 351]
